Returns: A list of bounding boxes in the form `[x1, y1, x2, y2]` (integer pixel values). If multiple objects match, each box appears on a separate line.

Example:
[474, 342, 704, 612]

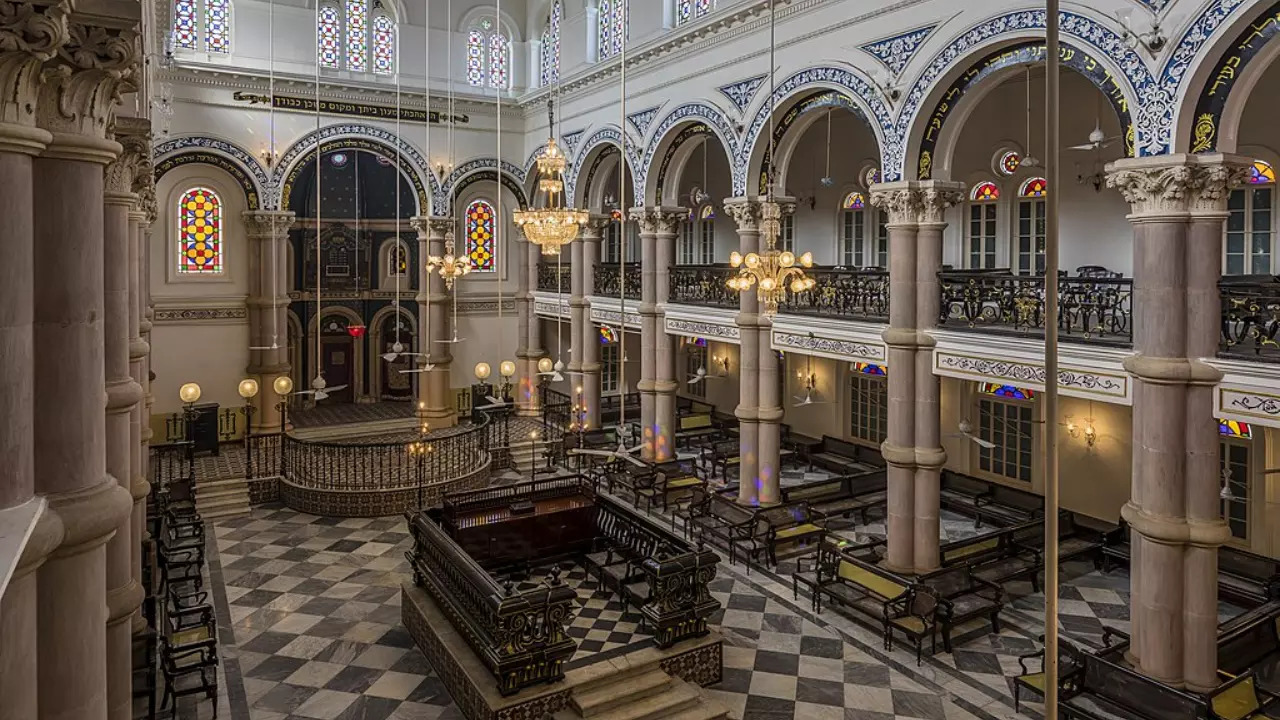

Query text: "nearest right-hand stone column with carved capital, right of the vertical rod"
[1107, 154, 1248, 691]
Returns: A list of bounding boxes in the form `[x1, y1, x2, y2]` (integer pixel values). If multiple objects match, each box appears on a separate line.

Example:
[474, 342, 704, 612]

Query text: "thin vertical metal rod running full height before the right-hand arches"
[1043, 0, 1062, 720]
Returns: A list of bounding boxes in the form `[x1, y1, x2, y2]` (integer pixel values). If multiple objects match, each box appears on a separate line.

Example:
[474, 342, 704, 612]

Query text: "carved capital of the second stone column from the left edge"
[37, 19, 138, 140]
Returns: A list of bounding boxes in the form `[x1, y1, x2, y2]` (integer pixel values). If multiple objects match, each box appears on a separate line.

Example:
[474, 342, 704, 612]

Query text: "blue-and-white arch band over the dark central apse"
[266, 123, 440, 210]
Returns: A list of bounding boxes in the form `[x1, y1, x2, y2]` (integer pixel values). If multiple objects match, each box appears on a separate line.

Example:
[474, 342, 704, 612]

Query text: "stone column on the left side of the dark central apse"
[241, 210, 293, 433]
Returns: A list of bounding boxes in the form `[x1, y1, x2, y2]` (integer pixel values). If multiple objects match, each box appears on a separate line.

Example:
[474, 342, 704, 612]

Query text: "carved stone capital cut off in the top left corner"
[0, 0, 67, 127]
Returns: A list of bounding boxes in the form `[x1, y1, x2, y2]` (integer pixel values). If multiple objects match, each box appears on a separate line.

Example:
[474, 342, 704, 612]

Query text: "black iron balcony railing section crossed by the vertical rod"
[938, 270, 1133, 346]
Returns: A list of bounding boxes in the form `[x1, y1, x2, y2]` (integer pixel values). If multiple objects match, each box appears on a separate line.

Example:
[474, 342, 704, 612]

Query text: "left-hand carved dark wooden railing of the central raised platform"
[406, 512, 577, 696]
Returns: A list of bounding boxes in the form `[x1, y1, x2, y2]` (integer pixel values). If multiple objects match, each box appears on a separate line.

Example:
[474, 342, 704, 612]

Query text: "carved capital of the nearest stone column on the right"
[1106, 152, 1252, 219]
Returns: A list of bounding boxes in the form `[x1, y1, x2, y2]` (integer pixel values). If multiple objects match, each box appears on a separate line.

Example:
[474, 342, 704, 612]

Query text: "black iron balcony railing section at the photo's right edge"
[1219, 275, 1280, 363]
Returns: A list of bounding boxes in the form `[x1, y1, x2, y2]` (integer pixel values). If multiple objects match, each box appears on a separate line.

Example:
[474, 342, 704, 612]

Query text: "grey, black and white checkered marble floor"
[182, 497, 1230, 720]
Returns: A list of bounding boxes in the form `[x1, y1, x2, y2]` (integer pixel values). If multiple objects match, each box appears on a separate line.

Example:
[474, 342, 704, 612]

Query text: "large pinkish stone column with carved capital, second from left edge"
[33, 8, 137, 720]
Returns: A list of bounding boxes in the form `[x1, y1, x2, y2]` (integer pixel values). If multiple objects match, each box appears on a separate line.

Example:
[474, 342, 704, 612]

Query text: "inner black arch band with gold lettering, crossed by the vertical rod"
[915, 41, 1135, 179]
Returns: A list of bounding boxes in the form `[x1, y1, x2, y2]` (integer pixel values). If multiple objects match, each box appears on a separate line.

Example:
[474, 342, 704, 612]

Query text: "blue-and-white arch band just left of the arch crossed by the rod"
[733, 67, 901, 196]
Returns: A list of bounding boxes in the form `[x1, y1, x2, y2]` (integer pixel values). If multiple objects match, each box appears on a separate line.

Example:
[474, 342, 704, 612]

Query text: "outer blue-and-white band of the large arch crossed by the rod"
[882, 10, 1157, 181]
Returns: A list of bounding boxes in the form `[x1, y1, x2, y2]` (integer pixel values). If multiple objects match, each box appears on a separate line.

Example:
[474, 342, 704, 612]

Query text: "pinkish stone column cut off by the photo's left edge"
[0, 7, 67, 720]
